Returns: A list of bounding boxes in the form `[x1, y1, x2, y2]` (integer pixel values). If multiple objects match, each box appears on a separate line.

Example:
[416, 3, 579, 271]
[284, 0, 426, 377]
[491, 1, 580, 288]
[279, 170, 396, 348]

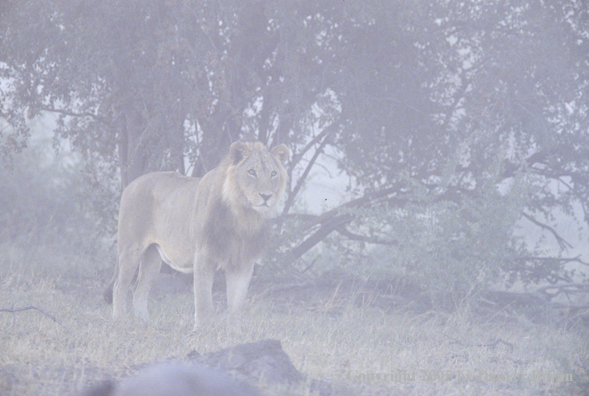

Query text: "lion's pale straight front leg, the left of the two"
[193, 254, 215, 328]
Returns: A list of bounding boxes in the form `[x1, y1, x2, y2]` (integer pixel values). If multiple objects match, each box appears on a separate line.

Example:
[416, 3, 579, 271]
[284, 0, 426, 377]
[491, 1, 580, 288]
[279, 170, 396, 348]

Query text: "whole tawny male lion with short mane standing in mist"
[105, 142, 290, 327]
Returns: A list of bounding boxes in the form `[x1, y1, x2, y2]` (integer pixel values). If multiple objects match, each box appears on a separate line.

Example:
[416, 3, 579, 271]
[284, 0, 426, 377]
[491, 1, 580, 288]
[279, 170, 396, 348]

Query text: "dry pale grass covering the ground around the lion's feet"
[0, 246, 589, 396]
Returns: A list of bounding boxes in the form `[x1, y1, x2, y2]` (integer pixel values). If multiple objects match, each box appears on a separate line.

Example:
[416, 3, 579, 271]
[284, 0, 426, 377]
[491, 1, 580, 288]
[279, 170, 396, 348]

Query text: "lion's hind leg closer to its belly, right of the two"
[133, 245, 162, 320]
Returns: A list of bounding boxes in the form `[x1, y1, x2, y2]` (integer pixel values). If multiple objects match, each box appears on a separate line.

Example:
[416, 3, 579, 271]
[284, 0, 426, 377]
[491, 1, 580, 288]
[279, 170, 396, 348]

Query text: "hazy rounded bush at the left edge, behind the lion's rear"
[0, 145, 108, 272]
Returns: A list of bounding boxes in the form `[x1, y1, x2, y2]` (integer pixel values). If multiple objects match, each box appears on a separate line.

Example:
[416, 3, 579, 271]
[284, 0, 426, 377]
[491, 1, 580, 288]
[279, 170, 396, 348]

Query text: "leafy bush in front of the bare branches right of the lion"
[340, 175, 529, 308]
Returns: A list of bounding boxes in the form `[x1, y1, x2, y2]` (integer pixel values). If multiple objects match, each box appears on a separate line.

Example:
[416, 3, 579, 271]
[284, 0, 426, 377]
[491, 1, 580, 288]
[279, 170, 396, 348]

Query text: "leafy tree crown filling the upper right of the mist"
[342, 1, 589, 288]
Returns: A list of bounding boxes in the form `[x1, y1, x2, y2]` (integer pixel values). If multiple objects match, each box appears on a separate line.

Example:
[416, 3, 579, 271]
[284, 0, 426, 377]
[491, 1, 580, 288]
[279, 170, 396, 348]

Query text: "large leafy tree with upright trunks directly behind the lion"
[0, 0, 340, 230]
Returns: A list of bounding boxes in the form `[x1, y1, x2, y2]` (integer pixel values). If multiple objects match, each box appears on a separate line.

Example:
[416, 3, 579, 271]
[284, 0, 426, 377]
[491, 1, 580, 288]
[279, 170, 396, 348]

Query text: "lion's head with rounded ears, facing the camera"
[223, 142, 290, 214]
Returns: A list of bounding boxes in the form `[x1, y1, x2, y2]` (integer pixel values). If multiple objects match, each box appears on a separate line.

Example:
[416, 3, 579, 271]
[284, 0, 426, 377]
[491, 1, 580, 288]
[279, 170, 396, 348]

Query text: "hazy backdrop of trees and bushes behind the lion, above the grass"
[0, 0, 589, 308]
